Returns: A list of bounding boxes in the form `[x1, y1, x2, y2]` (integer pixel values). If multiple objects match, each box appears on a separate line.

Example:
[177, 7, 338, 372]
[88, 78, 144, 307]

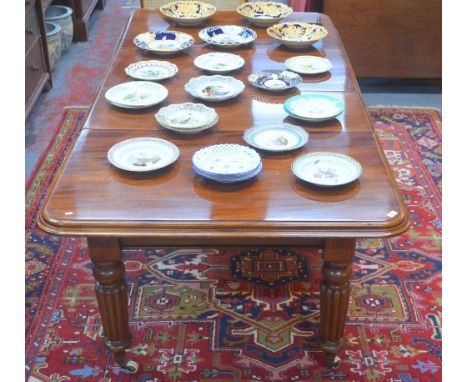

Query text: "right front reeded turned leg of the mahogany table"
[320, 239, 356, 367]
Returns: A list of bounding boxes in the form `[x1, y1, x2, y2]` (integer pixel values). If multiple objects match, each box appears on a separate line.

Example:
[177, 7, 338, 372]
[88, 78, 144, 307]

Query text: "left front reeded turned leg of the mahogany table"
[88, 238, 138, 367]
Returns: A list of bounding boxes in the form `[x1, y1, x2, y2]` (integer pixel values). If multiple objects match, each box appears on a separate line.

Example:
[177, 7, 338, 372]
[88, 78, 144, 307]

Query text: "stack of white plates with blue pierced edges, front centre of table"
[192, 144, 261, 178]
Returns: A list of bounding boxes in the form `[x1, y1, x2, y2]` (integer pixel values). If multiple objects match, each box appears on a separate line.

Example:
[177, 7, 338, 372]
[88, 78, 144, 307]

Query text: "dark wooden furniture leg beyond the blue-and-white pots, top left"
[54, 0, 106, 41]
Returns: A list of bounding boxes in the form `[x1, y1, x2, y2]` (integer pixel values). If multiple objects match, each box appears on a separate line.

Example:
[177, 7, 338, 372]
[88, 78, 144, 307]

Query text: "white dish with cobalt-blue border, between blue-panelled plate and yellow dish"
[198, 25, 257, 48]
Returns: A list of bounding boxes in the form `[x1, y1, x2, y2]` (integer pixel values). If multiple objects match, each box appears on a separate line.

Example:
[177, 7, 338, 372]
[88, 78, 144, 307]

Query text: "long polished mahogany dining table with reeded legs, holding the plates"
[38, 9, 409, 374]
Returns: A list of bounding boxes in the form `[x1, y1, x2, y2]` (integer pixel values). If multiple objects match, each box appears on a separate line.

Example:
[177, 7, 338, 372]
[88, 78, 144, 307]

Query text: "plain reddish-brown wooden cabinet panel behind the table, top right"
[323, 0, 442, 79]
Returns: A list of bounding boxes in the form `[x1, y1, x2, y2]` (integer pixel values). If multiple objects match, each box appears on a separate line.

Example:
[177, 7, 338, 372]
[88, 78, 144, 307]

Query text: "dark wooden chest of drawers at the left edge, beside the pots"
[25, 0, 51, 118]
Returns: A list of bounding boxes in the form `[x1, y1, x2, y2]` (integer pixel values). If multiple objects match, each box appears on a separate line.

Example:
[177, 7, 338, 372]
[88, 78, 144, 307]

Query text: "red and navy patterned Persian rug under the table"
[26, 108, 442, 382]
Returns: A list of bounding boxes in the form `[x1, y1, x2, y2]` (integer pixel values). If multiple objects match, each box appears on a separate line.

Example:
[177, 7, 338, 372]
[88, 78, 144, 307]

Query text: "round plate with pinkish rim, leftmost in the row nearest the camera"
[107, 137, 180, 172]
